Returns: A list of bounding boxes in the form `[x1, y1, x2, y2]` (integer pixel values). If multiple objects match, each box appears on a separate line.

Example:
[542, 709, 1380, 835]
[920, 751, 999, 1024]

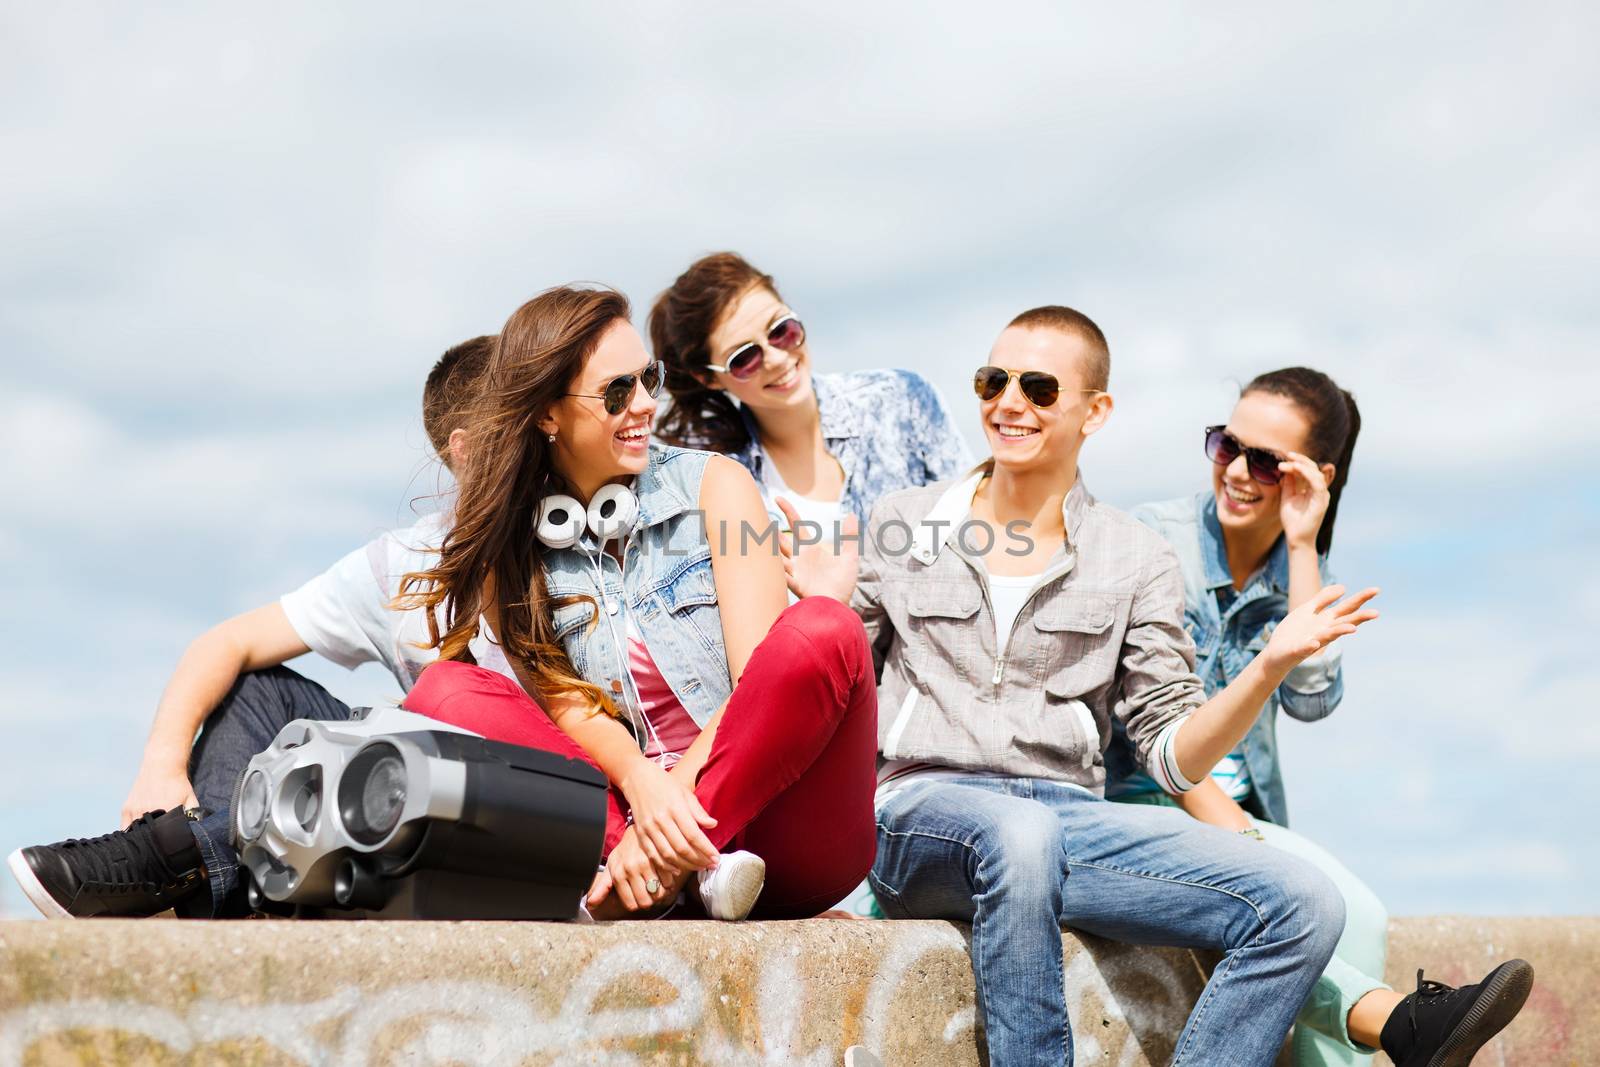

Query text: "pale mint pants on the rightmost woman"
[1117, 793, 1389, 1067]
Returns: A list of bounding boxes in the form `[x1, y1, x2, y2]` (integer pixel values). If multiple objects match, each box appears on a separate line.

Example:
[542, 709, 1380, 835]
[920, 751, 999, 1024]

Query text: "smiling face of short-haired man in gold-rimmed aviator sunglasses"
[978, 326, 1112, 477]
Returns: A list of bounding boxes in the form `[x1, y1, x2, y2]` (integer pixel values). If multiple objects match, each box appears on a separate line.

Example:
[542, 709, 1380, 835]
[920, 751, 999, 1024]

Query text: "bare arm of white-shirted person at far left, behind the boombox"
[122, 603, 310, 825]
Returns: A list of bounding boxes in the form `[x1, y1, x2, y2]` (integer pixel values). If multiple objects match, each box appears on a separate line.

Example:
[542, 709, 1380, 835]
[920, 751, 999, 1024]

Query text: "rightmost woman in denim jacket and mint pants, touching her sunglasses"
[1106, 366, 1531, 1067]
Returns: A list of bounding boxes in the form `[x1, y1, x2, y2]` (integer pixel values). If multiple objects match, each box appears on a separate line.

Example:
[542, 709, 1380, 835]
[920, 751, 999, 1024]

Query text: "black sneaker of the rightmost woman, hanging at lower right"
[1379, 960, 1533, 1067]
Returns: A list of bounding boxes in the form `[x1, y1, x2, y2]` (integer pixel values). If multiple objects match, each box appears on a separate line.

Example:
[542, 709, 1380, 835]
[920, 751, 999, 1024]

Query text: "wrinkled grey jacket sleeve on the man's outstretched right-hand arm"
[1114, 544, 1205, 793]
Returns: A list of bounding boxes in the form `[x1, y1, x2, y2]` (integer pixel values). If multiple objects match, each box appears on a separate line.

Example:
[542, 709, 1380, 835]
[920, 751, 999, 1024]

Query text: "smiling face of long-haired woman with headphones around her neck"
[539, 318, 656, 494]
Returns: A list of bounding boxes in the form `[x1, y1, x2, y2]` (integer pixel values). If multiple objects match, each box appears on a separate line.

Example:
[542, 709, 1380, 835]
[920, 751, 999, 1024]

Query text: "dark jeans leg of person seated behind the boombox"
[182, 667, 350, 917]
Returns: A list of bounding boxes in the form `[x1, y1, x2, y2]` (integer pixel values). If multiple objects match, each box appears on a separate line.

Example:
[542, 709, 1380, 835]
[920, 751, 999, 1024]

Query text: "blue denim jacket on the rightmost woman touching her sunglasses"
[1107, 490, 1344, 825]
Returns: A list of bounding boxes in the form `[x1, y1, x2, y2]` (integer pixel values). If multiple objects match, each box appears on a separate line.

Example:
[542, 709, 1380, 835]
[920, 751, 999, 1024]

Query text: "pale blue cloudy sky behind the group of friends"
[0, 3, 1600, 913]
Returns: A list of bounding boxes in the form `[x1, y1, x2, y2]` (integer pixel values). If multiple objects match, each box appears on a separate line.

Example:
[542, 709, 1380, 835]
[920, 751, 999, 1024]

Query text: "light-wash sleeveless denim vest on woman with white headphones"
[544, 445, 733, 726]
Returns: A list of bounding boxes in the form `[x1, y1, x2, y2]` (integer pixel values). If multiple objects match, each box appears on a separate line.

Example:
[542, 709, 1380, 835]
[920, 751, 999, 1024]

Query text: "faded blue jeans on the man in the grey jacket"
[869, 777, 1344, 1067]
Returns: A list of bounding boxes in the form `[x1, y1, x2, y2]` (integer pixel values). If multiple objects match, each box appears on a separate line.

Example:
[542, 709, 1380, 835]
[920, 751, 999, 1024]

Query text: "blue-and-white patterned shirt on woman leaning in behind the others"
[728, 370, 973, 525]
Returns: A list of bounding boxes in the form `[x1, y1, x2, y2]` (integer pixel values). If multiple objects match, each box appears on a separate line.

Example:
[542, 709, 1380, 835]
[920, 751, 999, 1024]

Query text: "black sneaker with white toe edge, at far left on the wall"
[6, 808, 205, 918]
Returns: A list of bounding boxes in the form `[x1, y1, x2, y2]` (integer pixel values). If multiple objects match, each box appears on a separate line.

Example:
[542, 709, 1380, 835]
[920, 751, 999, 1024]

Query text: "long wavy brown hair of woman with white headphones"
[395, 286, 629, 715]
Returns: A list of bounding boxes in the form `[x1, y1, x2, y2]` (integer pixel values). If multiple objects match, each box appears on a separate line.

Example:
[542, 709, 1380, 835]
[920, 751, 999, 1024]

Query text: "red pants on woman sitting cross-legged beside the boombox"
[405, 597, 878, 918]
